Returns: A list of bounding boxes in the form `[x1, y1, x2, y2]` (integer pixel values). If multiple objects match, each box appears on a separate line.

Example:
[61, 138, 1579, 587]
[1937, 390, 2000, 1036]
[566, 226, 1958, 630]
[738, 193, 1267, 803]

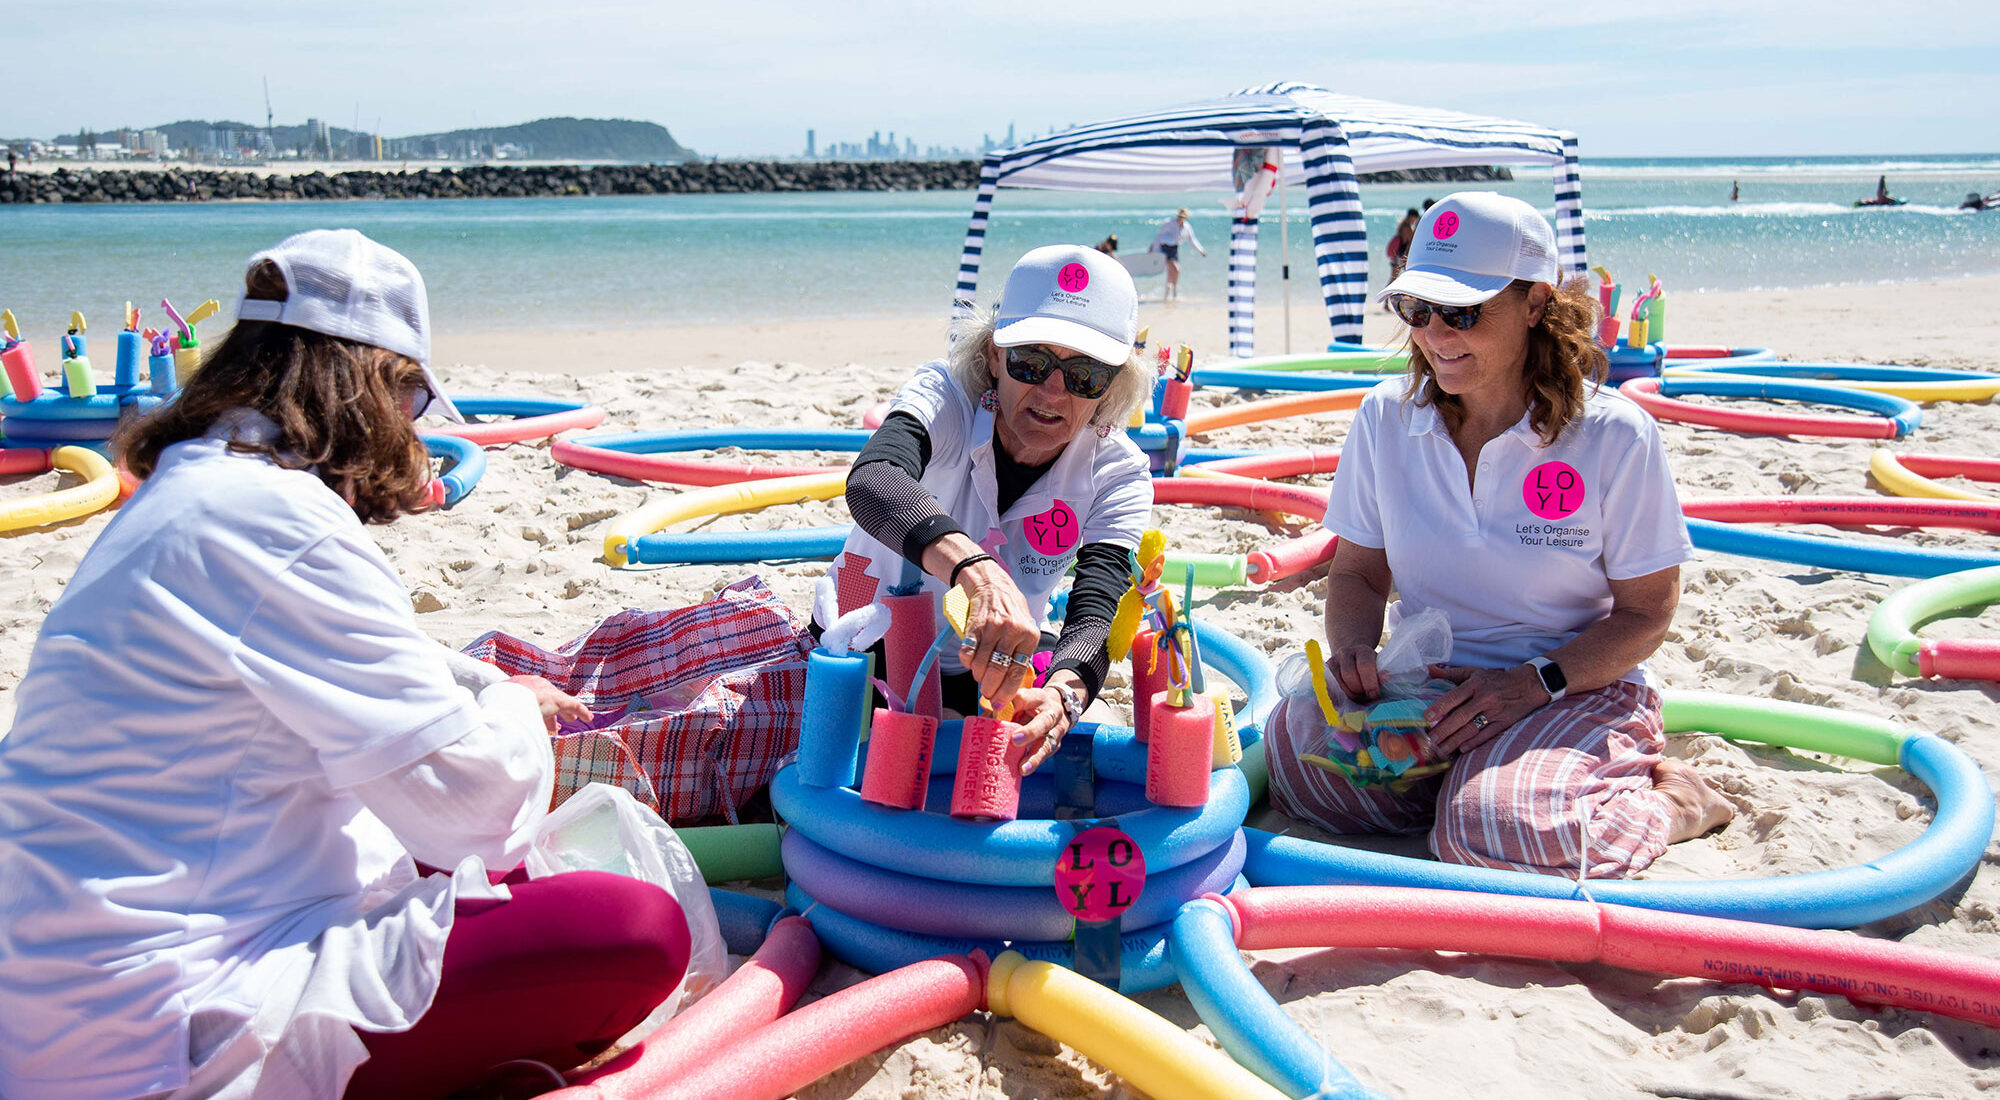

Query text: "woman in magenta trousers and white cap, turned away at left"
[0, 230, 690, 1100]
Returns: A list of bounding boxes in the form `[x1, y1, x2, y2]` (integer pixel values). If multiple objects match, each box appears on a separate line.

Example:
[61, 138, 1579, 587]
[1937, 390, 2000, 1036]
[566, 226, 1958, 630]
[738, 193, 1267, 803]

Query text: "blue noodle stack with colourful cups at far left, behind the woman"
[0, 330, 176, 454]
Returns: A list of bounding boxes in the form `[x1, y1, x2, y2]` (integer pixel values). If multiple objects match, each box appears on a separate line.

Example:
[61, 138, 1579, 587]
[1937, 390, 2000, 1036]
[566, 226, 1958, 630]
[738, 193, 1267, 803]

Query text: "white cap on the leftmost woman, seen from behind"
[236, 230, 466, 424]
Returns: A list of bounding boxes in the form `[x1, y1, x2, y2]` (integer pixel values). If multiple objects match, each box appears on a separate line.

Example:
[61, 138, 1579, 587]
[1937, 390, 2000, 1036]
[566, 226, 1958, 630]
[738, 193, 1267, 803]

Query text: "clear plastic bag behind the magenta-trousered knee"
[524, 782, 730, 1042]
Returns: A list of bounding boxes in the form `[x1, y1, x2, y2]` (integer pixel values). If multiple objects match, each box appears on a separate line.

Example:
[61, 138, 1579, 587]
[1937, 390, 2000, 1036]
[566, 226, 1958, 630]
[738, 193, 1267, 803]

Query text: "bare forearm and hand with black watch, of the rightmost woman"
[1424, 566, 1680, 752]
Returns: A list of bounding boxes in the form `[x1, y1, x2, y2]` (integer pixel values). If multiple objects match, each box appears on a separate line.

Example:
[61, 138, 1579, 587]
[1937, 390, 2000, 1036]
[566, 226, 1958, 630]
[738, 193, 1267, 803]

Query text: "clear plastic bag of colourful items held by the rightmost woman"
[1278, 608, 1456, 790]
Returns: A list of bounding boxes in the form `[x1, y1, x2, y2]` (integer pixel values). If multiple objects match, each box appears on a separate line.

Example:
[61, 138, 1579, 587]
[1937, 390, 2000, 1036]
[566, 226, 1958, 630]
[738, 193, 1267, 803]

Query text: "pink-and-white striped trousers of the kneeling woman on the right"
[1264, 682, 1674, 878]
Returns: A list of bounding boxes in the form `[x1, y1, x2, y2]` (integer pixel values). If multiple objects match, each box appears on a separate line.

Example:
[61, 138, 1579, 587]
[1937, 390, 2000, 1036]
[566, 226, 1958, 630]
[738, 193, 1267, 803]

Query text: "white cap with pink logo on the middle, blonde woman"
[994, 244, 1138, 364]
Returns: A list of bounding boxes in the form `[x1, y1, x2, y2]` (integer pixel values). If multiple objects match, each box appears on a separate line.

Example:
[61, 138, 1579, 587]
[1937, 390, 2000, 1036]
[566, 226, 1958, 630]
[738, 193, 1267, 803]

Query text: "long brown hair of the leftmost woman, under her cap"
[112, 260, 430, 524]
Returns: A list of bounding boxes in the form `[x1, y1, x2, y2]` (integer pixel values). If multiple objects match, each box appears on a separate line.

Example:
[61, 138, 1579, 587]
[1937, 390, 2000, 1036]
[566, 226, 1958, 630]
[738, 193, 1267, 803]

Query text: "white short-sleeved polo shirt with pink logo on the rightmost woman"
[1326, 378, 1694, 686]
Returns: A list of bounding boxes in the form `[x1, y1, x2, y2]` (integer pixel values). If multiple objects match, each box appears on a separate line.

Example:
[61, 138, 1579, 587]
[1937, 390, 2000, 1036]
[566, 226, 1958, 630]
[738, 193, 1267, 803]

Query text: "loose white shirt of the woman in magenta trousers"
[0, 414, 554, 1100]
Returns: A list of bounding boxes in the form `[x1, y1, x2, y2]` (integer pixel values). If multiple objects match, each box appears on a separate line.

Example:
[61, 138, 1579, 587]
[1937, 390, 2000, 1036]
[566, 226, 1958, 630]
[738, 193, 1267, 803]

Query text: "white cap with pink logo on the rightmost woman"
[1376, 190, 1556, 306]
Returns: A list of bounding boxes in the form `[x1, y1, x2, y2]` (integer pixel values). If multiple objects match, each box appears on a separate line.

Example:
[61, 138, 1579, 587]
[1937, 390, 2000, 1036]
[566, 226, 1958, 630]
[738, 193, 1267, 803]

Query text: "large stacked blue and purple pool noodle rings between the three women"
[772, 600, 1268, 992]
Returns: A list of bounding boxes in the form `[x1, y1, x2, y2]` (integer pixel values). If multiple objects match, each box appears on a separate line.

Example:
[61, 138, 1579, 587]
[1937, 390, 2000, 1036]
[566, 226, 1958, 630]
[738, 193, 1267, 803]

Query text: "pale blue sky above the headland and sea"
[15, 0, 2000, 160]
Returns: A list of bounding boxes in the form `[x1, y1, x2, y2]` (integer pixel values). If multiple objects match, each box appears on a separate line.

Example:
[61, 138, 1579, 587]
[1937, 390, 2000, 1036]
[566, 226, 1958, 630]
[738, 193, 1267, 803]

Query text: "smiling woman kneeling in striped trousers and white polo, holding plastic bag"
[1270, 192, 1732, 878]
